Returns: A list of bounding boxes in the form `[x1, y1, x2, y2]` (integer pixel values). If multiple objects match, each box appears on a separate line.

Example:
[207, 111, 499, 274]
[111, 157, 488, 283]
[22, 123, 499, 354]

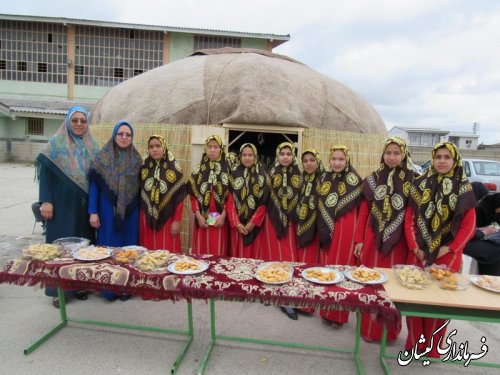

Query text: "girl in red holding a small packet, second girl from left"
[188, 135, 229, 256]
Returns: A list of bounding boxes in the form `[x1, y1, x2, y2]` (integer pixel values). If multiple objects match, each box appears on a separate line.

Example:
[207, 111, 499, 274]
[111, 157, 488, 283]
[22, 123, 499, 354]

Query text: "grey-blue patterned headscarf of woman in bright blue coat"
[89, 120, 142, 230]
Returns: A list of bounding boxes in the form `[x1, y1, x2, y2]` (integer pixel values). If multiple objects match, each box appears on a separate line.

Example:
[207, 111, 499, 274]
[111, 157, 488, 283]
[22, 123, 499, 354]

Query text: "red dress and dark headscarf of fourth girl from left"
[262, 142, 302, 262]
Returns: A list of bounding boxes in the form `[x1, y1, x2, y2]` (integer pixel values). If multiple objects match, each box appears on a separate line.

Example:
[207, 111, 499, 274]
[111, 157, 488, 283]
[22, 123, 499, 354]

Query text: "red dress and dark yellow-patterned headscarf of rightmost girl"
[405, 142, 476, 358]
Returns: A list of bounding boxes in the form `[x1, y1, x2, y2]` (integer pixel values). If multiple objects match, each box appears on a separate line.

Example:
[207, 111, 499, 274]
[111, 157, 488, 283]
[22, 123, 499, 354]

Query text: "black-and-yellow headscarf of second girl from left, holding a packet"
[188, 135, 229, 220]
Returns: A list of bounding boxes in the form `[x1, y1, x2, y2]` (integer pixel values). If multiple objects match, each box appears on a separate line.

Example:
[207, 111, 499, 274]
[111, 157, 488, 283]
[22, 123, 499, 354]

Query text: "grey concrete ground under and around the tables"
[0, 164, 500, 375]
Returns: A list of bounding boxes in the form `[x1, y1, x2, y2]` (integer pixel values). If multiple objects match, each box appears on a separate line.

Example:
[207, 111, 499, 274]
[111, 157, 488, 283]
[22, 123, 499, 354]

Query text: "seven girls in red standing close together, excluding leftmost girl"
[185, 136, 476, 356]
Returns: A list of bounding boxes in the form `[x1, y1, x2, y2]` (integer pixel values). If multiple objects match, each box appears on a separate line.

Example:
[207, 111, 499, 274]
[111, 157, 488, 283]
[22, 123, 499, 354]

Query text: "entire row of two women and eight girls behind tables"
[38, 107, 476, 356]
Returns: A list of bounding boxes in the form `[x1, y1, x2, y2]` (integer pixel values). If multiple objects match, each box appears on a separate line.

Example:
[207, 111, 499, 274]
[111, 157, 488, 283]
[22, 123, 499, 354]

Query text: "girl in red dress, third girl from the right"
[317, 145, 363, 326]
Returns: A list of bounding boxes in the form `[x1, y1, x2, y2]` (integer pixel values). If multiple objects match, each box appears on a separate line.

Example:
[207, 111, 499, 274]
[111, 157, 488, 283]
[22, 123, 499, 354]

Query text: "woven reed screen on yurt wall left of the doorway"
[91, 124, 192, 251]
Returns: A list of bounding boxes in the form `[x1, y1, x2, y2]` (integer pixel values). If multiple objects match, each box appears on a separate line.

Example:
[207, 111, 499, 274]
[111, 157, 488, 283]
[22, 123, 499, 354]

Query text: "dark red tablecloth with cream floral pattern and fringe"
[0, 255, 401, 328]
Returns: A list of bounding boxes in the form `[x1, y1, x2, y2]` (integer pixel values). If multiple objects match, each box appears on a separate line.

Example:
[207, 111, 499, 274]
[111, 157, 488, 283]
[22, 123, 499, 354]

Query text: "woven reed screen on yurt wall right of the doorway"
[302, 129, 387, 177]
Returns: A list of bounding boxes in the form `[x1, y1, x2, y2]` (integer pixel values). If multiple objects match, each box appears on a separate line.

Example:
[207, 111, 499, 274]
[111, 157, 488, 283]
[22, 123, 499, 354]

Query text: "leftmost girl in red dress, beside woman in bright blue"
[139, 135, 187, 253]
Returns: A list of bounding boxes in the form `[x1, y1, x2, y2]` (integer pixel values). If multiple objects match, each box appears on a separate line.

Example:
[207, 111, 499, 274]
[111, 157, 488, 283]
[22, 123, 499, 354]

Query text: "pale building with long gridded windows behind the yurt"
[0, 14, 290, 161]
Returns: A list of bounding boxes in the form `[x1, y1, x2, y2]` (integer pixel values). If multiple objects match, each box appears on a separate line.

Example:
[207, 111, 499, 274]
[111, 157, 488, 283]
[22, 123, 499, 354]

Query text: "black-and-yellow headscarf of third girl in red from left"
[229, 143, 269, 246]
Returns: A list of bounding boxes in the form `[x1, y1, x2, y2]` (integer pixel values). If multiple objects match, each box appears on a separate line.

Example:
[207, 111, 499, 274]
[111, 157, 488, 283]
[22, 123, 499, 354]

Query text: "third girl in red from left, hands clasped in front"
[226, 143, 269, 259]
